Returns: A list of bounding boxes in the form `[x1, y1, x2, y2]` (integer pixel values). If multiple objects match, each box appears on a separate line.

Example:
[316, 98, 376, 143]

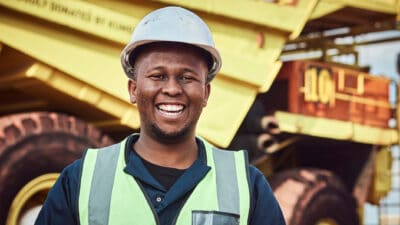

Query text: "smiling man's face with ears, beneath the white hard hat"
[129, 43, 210, 142]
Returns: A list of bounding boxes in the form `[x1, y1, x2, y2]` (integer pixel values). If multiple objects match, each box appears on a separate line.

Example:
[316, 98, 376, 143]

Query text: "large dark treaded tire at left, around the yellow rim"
[0, 112, 112, 224]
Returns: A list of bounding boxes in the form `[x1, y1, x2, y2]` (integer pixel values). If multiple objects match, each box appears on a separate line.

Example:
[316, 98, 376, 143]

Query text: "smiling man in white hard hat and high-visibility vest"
[36, 7, 284, 225]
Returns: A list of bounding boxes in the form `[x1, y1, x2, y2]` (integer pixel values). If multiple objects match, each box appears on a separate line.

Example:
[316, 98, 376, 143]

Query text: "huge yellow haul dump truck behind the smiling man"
[0, 0, 399, 225]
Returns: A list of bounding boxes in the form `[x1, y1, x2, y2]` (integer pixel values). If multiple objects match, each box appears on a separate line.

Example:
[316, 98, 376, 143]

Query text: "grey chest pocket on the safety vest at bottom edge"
[192, 210, 240, 225]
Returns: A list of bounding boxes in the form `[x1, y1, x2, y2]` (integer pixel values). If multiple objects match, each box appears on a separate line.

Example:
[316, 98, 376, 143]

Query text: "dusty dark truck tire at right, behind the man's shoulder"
[268, 169, 360, 225]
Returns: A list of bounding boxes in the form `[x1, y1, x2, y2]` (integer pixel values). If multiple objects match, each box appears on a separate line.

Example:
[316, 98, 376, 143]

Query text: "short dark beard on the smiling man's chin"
[150, 123, 191, 143]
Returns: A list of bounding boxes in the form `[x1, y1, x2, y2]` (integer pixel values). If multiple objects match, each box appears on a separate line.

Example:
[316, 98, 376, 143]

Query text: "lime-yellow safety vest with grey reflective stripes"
[78, 135, 250, 225]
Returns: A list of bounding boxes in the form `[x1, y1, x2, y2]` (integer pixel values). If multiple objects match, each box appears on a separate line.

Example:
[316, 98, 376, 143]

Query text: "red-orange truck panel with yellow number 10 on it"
[278, 61, 392, 128]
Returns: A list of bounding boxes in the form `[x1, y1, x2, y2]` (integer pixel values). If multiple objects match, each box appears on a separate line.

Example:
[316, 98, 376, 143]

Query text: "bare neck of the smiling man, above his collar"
[133, 133, 198, 169]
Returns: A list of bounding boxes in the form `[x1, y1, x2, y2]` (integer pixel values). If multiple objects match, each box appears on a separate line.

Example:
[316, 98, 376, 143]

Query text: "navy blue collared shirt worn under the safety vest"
[35, 136, 285, 225]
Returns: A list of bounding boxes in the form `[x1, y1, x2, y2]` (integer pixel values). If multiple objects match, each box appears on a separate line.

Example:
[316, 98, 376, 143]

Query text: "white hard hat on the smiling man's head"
[121, 6, 222, 80]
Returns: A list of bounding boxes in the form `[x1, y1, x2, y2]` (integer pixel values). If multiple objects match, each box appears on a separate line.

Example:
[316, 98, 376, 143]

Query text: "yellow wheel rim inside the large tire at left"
[6, 173, 59, 225]
